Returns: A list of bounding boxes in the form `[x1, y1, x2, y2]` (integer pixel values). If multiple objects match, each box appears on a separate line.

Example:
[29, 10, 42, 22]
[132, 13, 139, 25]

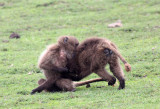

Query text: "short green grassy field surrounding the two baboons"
[0, 0, 160, 109]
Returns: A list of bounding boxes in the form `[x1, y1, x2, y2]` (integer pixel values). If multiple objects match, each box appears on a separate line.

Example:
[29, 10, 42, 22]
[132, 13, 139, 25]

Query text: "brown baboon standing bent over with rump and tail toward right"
[71, 38, 131, 89]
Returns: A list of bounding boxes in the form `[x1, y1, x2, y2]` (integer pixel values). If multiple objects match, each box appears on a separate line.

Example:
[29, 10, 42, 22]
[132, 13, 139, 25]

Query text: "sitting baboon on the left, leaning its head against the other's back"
[31, 36, 79, 94]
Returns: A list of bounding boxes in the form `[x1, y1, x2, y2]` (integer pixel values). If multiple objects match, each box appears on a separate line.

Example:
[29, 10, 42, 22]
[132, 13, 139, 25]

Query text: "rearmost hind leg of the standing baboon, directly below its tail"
[109, 58, 125, 90]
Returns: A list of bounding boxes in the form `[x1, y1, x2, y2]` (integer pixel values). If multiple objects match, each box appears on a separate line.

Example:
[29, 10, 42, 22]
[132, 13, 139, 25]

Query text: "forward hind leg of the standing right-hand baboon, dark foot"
[95, 69, 116, 85]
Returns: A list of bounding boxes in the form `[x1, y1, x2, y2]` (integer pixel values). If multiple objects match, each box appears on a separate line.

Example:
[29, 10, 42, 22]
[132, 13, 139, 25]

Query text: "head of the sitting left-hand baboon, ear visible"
[58, 36, 79, 59]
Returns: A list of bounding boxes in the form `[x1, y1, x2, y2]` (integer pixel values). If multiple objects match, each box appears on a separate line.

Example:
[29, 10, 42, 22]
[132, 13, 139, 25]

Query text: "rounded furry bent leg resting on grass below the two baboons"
[56, 78, 75, 91]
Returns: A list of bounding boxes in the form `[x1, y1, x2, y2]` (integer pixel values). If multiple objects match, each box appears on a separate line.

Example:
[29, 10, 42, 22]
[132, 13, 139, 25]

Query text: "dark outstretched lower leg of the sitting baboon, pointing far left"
[31, 78, 56, 94]
